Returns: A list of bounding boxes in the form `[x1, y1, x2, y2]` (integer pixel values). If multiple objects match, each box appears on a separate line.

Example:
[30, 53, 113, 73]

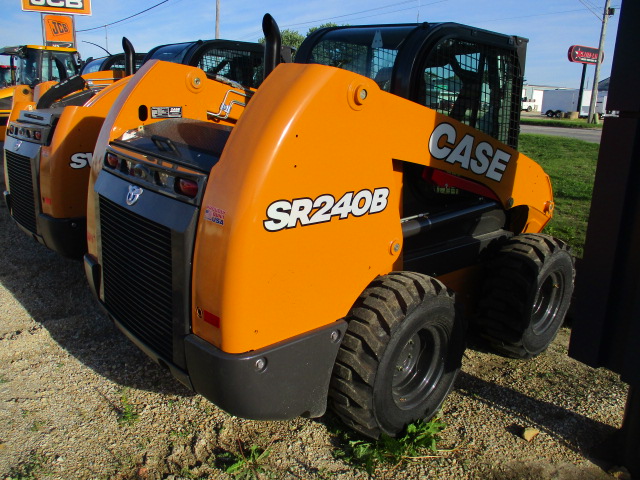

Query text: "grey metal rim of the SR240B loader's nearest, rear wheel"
[391, 327, 447, 410]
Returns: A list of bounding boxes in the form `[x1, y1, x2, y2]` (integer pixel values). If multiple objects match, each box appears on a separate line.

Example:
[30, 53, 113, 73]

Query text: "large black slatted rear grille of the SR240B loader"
[100, 197, 173, 361]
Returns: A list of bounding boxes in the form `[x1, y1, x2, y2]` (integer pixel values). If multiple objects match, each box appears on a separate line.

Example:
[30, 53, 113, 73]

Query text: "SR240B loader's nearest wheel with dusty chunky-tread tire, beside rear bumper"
[329, 272, 466, 438]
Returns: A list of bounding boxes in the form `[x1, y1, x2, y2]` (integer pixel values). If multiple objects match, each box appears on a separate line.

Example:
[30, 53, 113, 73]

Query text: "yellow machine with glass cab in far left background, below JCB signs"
[0, 45, 81, 142]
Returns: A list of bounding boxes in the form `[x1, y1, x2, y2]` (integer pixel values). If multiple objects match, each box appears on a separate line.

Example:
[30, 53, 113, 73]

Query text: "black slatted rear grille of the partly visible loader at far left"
[5, 150, 36, 233]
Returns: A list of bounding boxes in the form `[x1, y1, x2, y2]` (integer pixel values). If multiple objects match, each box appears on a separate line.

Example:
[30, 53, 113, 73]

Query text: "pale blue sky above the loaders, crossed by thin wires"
[0, 0, 620, 88]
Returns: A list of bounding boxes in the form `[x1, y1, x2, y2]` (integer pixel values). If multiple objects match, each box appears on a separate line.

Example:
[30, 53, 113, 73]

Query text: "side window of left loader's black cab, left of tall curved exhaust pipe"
[197, 48, 263, 88]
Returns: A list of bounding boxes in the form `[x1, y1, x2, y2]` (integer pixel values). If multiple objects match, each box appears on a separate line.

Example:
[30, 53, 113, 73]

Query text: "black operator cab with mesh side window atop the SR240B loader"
[296, 23, 527, 148]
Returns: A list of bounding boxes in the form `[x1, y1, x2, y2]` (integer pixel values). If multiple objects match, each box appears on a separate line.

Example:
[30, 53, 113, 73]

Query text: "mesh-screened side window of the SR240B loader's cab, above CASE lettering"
[418, 39, 520, 147]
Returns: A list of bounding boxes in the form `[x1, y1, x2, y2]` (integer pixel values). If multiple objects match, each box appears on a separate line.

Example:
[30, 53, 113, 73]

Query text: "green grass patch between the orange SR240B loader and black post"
[519, 134, 600, 257]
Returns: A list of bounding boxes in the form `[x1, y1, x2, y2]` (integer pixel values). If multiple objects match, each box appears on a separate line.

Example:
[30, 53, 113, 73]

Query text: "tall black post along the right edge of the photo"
[569, 0, 640, 478]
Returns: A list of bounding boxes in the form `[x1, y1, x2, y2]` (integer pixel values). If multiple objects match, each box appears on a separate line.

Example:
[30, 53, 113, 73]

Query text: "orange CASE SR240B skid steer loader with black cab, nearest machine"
[85, 17, 574, 437]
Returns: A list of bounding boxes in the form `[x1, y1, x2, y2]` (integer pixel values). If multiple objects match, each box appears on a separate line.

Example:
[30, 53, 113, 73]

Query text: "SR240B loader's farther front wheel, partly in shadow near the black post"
[474, 233, 575, 358]
